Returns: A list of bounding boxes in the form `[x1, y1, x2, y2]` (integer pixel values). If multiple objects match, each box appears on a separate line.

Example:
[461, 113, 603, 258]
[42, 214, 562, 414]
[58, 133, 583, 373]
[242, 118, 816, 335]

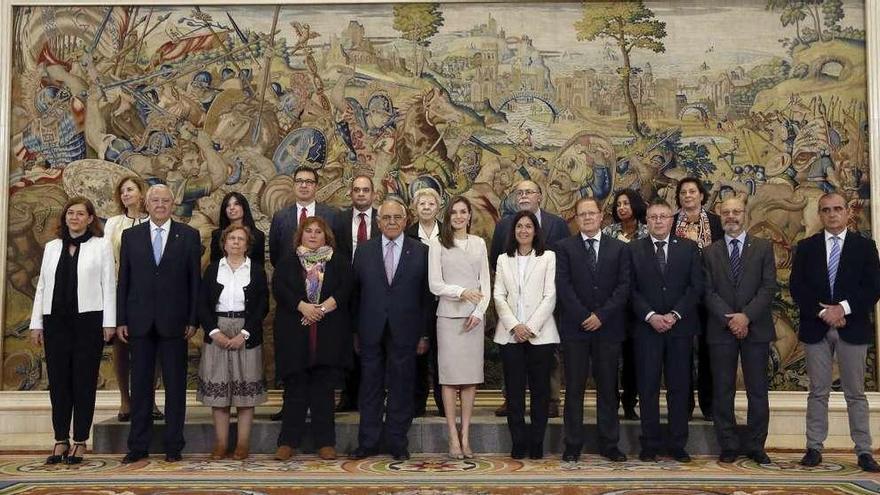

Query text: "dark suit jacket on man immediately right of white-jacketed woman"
[555, 233, 630, 342]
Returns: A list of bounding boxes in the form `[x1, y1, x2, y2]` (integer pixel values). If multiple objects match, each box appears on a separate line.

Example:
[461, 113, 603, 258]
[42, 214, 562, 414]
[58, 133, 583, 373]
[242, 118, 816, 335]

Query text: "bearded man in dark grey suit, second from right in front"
[703, 197, 776, 464]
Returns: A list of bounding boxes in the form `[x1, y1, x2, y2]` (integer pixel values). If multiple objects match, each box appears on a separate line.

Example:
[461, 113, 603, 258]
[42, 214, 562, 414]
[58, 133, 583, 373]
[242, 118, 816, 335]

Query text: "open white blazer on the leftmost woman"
[31, 237, 116, 329]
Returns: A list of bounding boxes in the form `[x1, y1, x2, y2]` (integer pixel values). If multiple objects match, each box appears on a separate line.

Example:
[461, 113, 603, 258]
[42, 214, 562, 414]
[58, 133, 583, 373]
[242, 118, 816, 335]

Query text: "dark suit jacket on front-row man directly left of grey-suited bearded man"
[628, 236, 703, 338]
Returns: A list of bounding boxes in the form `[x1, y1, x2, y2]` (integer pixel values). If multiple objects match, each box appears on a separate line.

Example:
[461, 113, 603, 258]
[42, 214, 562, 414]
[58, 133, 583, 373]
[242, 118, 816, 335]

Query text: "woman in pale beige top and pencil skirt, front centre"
[428, 197, 492, 459]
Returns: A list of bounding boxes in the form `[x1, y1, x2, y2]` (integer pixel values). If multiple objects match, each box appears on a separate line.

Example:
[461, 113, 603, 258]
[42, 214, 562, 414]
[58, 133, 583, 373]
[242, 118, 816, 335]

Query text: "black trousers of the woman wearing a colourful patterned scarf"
[278, 366, 341, 448]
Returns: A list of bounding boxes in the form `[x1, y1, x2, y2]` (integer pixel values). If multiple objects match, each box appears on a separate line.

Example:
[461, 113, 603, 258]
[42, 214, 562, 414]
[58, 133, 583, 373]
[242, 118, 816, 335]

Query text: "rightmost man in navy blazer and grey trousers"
[791, 193, 880, 472]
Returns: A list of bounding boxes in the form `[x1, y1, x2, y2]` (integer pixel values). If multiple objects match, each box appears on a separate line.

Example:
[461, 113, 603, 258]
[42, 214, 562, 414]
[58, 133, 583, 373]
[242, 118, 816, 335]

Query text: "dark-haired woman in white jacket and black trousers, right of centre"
[493, 210, 559, 459]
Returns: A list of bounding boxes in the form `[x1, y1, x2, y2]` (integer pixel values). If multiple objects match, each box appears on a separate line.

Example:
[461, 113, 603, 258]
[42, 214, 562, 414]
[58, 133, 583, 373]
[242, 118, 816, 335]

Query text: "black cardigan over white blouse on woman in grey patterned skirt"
[199, 260, 269, 349]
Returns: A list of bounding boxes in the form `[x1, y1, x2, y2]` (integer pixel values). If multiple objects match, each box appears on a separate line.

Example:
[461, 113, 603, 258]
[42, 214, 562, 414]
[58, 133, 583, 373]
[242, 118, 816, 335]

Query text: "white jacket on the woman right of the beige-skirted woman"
[493, 250, 559, 345]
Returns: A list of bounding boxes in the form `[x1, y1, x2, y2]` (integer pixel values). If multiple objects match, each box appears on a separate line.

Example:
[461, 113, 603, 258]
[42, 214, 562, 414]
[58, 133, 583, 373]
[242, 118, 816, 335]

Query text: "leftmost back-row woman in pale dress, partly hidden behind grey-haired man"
[104, 176, 163, 422]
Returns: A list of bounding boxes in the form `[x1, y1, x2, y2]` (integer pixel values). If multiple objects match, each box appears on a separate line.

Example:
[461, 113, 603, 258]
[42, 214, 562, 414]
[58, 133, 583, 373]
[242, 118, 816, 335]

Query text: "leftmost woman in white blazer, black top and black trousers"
[30, 197, 116, 464]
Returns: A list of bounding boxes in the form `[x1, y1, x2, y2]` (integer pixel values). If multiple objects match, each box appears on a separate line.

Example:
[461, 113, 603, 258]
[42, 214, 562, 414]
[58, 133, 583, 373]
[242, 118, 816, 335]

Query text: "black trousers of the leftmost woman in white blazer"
[43, 311, 104, 442]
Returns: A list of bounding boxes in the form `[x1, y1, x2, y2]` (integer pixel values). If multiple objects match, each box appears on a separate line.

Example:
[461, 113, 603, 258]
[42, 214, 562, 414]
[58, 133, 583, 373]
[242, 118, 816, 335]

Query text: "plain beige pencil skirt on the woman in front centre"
[437, 316, 485, 385]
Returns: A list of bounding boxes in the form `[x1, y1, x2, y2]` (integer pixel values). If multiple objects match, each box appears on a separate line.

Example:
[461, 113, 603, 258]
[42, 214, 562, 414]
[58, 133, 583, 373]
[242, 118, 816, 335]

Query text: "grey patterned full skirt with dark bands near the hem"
[196, 316, 266, 407]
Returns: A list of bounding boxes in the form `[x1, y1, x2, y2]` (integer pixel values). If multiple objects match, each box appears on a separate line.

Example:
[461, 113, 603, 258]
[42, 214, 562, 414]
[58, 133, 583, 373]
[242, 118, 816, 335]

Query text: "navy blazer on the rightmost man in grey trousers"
[791, 230, 880, 345]
